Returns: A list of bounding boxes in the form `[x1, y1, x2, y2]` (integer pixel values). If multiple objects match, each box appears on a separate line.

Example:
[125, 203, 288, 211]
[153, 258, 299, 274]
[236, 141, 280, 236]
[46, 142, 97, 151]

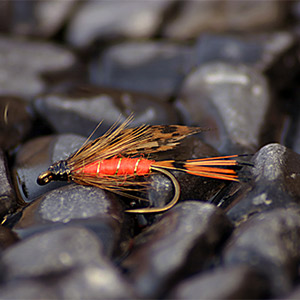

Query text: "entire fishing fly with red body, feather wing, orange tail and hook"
[37, 116, 246, 213]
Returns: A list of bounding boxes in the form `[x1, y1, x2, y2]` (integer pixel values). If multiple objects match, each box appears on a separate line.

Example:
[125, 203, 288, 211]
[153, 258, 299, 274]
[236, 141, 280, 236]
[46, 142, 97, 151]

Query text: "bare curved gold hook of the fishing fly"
[125, 167, 180, 214]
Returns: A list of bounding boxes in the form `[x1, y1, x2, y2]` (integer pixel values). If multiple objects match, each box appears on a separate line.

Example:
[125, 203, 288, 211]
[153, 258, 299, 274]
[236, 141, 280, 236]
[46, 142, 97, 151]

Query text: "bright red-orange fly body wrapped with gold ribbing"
[73, 157, 154, 177]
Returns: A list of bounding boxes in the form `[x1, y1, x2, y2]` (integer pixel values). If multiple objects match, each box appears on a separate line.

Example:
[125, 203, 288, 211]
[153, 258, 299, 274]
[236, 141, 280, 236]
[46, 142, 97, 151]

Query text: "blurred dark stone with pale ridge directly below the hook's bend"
[123, 201, 232, 298]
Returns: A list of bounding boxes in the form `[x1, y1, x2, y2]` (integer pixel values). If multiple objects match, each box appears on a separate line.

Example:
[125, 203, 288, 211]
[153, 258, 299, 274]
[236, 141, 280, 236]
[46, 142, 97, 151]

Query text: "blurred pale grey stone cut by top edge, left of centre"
[66, 0, 171, 48]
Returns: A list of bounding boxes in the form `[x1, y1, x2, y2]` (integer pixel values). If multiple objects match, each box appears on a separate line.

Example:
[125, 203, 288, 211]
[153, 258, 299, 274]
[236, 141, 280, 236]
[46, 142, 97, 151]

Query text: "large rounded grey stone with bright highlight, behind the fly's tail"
[177, 63, 271, 153]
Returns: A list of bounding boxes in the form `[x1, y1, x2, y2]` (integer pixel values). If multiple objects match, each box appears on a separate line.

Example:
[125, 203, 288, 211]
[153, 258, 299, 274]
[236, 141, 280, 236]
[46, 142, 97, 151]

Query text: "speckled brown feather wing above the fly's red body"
[68, 122, 203, 168]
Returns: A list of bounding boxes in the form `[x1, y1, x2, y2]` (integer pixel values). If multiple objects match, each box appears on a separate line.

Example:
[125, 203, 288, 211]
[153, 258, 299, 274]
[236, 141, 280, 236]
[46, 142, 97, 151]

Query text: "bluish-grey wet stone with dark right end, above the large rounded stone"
[196, 31, 299, 83]
